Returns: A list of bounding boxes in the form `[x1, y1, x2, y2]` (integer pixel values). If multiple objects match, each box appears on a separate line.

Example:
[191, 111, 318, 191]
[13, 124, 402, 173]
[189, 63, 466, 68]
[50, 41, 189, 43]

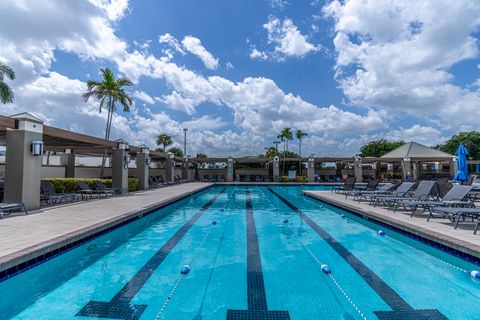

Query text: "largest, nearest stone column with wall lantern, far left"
[5, 113, 43, 210]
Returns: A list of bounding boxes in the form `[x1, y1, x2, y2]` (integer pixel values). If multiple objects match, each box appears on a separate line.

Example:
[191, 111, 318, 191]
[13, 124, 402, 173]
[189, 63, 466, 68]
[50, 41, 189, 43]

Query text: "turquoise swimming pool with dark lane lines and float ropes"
[0, 185, 480, 320]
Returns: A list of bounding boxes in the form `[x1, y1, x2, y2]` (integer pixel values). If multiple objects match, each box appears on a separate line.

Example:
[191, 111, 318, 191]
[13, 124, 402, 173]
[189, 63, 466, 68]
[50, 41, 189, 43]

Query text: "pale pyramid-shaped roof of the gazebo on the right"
[380, 142, 454, 161]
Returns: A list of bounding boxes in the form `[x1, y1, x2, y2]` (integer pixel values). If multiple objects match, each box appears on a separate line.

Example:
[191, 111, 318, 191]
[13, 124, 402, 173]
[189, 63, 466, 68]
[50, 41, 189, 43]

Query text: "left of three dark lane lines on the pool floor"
[76, 188, 227, 320]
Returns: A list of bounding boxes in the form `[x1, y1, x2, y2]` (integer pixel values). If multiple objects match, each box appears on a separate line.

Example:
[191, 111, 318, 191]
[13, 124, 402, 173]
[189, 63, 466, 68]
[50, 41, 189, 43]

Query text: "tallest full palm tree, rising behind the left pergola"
[83, 68, 133, 178]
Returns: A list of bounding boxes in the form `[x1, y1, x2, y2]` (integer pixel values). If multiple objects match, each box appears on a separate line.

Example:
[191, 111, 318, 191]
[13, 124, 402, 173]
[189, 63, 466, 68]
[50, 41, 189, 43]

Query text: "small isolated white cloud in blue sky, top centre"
[263, 17, 319, 60]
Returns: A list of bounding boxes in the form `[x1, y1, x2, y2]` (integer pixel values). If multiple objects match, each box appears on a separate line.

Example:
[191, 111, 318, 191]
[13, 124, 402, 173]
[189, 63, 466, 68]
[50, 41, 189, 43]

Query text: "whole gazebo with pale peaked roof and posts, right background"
[380, 142, 456, 180]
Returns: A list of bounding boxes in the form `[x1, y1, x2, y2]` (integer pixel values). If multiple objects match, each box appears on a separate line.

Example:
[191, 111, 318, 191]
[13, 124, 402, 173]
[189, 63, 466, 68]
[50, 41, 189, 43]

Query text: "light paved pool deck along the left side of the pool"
[0, 182, 212, 272]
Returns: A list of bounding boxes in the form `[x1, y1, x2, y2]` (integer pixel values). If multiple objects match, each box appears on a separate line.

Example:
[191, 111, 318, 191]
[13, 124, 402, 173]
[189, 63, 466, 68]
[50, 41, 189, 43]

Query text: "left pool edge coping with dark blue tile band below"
[0, 184, 214, 282]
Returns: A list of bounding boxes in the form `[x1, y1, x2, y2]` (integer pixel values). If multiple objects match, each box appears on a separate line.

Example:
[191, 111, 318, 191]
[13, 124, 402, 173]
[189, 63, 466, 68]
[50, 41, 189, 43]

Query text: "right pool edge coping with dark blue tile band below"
[302, 190, 480, 264]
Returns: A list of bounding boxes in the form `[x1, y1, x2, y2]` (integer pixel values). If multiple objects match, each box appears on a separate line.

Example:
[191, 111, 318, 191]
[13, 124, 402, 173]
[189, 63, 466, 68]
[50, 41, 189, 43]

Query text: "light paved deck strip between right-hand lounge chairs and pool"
[303, 190, 480, 259]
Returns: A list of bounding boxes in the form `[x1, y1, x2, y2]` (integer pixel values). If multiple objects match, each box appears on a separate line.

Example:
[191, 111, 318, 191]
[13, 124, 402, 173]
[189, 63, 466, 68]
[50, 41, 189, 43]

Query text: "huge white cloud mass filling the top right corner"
[323, 0, 480, 128]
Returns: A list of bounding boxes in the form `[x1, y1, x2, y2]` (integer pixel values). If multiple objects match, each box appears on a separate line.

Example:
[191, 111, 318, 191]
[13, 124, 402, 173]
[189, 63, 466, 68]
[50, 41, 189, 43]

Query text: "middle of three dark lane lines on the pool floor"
[227, 191, 290, 320]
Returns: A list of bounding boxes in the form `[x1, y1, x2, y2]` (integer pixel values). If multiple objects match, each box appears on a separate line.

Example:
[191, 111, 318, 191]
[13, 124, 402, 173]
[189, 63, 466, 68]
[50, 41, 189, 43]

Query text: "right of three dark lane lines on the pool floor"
[268, 188, 448, 320]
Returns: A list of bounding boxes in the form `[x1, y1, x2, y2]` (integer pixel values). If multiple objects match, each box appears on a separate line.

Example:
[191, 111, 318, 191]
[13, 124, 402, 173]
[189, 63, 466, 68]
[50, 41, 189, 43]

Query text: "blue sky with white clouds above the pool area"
[0, 0, 480, 156]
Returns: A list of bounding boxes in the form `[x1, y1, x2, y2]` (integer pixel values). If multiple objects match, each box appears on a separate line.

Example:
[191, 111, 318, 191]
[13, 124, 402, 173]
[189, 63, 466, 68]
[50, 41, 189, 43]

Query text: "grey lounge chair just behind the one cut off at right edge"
[402, 186, 473, 221]
